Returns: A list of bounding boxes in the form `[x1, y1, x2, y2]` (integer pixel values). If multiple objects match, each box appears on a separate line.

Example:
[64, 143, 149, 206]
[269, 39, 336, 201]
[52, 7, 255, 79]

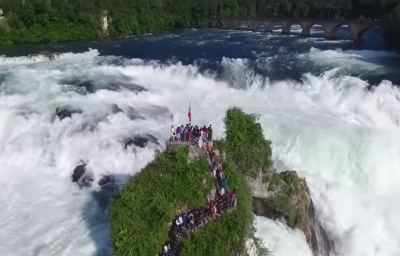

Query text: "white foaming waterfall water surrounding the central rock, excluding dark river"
[0, 50, 400, 256]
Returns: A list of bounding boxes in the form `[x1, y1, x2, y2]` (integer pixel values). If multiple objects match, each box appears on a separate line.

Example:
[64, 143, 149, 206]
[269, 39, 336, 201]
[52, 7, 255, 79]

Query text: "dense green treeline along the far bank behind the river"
[0, 0, 398, 44]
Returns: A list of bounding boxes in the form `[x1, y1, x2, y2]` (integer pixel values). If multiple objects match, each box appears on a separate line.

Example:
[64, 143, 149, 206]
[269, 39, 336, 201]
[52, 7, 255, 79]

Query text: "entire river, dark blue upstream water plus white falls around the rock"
[0, 28, 400, 256]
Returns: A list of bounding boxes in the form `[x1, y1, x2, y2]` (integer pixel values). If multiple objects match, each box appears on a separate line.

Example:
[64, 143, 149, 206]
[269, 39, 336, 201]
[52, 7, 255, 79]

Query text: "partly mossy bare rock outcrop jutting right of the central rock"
[247, 171, 334, 256]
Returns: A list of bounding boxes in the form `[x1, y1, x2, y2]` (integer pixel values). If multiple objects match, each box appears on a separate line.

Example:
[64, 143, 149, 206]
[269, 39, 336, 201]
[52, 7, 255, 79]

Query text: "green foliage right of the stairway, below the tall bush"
[180, 162, 253, 256]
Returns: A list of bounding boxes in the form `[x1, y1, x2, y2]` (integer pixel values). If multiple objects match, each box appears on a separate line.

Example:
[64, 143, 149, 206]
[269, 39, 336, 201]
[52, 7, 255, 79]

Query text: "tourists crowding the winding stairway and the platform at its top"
[161, 127, 237, 256]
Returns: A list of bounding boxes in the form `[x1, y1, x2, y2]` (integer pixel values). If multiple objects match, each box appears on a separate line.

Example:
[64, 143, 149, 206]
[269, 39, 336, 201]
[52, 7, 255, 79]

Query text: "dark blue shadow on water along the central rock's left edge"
[83, 174, 131, 256]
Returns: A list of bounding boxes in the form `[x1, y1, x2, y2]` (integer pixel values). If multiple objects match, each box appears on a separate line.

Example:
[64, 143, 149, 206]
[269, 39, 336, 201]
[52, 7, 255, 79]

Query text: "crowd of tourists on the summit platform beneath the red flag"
[170, 124, 212, 142]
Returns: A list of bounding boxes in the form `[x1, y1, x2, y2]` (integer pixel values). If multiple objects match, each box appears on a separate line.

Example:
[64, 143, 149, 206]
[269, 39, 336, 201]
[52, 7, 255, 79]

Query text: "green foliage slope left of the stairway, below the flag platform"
[110, 146, 214, 256]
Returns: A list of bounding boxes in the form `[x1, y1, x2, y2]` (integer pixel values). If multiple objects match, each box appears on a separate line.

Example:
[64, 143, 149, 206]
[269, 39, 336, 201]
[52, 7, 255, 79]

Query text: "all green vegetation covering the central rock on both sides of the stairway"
[110, 108, 271, 256]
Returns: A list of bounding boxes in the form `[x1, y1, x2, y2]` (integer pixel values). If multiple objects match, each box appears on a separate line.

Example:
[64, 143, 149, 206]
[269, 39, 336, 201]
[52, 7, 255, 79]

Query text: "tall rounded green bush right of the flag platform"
[217, 107, 272, 175]
